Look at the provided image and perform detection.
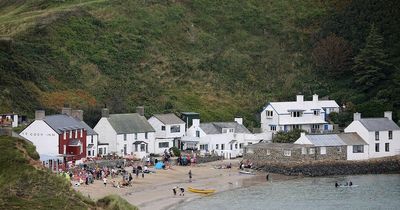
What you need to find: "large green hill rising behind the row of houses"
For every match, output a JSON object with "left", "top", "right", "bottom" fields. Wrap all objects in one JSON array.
[{"left": 0, "top": 0, "right": 400, "bottom": 127}]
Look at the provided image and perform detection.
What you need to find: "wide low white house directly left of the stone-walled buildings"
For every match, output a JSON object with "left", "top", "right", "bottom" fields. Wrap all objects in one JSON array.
[{"left": 186, "top": 118, "right": 260, "bottom": 158}]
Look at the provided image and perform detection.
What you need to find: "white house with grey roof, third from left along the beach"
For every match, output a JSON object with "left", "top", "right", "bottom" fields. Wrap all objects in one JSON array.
[{"left": 148, "top": 114, "right": 185, "bottom": 154}]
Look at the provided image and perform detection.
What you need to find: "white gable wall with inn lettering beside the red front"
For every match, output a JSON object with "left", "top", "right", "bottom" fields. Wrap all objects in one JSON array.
[{"left": 20, "top": 120, "right": 59, "bottom": 155}]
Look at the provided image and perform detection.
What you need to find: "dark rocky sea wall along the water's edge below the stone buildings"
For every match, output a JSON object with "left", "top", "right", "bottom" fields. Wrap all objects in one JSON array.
[{"left": 254, "top": 156, "right": 400, "bottom": 176}]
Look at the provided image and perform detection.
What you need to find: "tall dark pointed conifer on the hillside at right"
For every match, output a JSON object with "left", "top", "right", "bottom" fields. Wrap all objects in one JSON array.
[{"left": 353, "top": 24, "right": 392, "bottom": 91}]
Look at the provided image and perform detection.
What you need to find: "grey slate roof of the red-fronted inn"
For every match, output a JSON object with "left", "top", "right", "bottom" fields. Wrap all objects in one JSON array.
[{"left": 43, "top": 114, "right": 85, "bottom": 134}]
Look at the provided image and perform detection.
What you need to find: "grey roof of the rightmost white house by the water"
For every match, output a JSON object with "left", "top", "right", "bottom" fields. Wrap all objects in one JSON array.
[{"left": 359, "top": 117, "right": 400, "bottom": 131}]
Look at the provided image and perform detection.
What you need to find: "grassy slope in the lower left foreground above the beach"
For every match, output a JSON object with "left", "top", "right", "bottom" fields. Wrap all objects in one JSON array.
[{"left": 0, "top": 137, "right": 136, "bottom": 210}]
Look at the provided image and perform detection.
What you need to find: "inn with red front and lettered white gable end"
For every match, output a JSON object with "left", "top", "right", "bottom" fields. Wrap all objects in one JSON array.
[{"left": 20, "top": 109, "right": 88, "bottom": 160}]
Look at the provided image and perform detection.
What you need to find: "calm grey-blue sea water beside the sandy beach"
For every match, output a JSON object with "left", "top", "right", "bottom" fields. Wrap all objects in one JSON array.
[{"left": 175, "top": 174, "right": 400, "bottom": 210}]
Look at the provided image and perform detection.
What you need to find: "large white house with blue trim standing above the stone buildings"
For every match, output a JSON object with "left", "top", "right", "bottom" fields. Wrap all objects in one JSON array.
[{"left": 261, "top": 95, "right": 339, "bottom": 133}]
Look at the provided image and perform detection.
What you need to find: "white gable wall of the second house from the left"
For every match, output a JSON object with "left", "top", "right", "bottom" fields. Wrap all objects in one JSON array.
[{"left": 93, "top": 117, "right": 117, "bottom": 154}]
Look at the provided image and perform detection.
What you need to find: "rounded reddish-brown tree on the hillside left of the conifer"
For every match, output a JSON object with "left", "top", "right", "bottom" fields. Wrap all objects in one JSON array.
[{"left": 312, "top": 34, "right": 353, "bottom": 77}]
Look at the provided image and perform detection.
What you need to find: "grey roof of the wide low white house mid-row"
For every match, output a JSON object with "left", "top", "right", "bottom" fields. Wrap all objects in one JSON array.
[{"left": 200, "top": 122, "right": 250, "bottom": 134}]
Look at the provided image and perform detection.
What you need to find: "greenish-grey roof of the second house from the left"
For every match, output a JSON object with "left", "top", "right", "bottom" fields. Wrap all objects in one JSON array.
[{"left": 108, "top": 113, "right": 155, "bottom": 134}]
